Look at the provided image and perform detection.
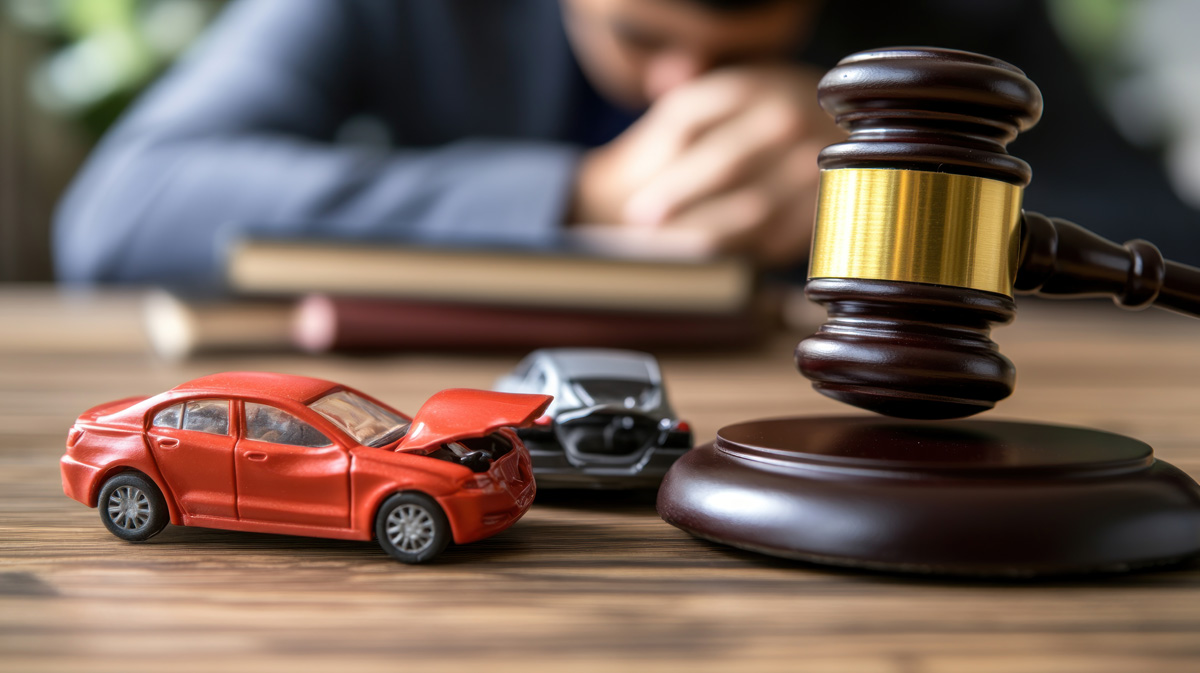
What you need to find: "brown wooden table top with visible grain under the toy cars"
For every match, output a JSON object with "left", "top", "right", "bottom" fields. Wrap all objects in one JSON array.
[{"left": 0, "top": 287, "right": 1200, "bottom": 673}]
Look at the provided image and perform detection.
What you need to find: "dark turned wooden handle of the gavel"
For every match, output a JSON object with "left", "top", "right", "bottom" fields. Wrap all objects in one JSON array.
[{"left": 1013, "top": 211, "right": 1200, "bottom": 317}]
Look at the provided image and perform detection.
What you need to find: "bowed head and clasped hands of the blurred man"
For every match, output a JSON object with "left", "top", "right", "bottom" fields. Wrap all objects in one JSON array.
[{"left": 564, "top": 0, "right": 841, "bottom": 265}]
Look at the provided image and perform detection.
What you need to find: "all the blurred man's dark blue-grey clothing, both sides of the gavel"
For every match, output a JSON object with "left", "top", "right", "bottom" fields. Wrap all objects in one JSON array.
[{"left": 55, "top": 0, "right": 1200, "bottom": 284}]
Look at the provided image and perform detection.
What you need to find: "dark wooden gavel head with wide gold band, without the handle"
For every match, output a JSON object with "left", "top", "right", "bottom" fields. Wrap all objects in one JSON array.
[{"left": 796, "top": 48, "right": 1042, "bottom": 419}]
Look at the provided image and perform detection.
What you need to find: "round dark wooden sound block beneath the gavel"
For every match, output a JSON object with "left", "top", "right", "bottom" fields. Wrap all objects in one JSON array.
[{"left": 658, "top": 416, "right": 1200, "bottom": 576}]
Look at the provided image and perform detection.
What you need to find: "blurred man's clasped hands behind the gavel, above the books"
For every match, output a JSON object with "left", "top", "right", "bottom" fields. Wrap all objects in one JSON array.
[{"left": 572, "top": 66, "right": 845, "bottom": 265}]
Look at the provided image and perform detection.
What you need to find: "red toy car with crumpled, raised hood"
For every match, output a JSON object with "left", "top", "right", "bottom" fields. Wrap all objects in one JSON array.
[{"left": 61, "top": 372, "right": 551, "bottom": 563}]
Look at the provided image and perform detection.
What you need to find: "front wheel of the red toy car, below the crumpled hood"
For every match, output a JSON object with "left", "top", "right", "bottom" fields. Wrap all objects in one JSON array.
[{"left": 376, "top": 493, "right": 450, "bottom": 563}]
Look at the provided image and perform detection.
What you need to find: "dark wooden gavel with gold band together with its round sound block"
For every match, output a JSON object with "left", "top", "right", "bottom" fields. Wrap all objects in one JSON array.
[{"left": 659, "top": 48, "right": 1200, "bottom": 576}]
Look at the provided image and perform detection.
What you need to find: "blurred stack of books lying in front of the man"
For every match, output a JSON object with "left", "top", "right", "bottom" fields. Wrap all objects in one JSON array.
[{"left": 146, "top": 229, "right": 763, "bottom": 359}]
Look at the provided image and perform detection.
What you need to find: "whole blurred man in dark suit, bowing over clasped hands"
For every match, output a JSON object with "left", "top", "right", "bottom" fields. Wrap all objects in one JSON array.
[{"left": 55, "top": 0, "right": 1200, "bottom": 284}]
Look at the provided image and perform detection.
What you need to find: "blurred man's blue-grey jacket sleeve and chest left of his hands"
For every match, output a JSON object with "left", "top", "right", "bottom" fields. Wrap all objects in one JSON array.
[{"left": 55, "top": 0, "right": 604, "bottom": 284}]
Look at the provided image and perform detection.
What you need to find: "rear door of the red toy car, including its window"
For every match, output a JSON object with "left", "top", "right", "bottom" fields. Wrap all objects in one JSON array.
[{"left": 146, "top": 399, "right": 238, "bottom": 518}]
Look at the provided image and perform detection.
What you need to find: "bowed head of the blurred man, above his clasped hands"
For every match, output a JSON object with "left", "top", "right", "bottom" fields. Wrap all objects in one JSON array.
[{"left": 562, "top": 0, "right": 820, "bottom": 108}]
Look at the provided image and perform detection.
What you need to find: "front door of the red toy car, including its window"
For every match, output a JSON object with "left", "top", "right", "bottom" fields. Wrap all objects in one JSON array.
[{"left": 234, "top": 402, "right": 350, "bottom": 528}]
